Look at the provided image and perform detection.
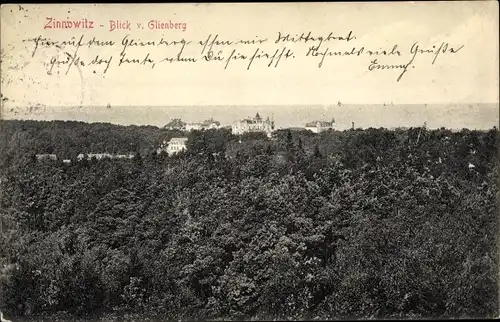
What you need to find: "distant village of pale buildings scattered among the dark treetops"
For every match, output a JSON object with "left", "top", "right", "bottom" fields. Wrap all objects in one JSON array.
[{"left": 36, "top": 113, "right": 335, "bottom": 164}]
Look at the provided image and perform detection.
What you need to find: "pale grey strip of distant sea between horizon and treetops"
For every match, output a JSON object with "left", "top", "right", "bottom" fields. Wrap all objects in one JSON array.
[{"left": 2, "top": 103, "right": 499, "bottom": 130}]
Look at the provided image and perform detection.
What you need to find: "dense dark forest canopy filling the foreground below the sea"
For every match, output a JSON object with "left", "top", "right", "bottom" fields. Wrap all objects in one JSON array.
[{"left": 0, "top": 121, "right": 499, "bottom": 319}]
